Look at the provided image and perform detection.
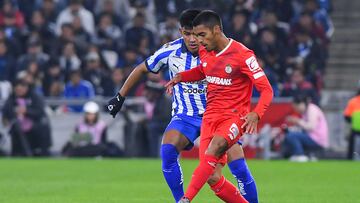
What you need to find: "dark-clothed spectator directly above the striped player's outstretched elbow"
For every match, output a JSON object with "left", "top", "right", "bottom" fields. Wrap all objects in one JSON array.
[{"left": 125, "top": 13, "right": 155, "bottom": 52}]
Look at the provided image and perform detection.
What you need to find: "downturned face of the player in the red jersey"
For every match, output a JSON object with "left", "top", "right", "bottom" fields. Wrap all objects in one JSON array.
[{"left": 194, "top": 25, "right": 216, "bottom": 51}]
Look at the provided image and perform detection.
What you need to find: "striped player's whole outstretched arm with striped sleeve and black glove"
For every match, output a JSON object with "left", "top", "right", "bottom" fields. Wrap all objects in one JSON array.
[{"left": 107, "top": 45, "right": 173, "bottom": 118}]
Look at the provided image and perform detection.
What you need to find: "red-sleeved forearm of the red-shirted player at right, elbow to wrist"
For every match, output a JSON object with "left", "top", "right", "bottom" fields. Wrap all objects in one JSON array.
[{"left": 254, "top": 79, "right": 274, "bottom": 118}]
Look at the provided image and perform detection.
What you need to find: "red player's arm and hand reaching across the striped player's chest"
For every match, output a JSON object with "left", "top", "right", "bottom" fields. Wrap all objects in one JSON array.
[{"left": 165, "top": 64, "right": 205, "bottom": 94}]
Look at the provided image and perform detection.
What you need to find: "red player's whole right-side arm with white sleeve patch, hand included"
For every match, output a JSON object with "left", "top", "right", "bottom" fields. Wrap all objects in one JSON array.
[{"left": 241, "top": 51, "right": 274, "bottom": 134}]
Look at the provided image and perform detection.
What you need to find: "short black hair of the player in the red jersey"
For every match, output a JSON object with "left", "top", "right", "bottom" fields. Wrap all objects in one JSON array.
[{"left": 193, "top": 10, "right": 223, "bottom": 30}]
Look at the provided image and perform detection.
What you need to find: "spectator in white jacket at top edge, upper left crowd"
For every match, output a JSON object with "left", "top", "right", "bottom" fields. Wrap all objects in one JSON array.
[{"left": 56, "top": 0, "right": 95, "bottom": 35}]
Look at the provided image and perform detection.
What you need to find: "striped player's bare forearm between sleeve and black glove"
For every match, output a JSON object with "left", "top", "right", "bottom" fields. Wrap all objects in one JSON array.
[{"left": 119, "top": 63, "right": 148, "bottom": 97}]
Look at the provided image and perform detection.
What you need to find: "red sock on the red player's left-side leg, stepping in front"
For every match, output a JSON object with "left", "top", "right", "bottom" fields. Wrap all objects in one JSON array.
[{"left": 184, "top": 155, "right": 218, "bottom": 200}]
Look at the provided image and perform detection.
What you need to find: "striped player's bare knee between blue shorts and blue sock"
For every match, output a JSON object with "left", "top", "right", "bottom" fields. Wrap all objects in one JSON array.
[{"left": 162, "top": 129, "right": 190, "bottom": 152}]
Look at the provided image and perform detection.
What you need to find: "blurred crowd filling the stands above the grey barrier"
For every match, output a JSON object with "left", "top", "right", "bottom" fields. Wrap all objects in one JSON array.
[{"left": 0, "top": 0, "right": 334, "bottom": 104}]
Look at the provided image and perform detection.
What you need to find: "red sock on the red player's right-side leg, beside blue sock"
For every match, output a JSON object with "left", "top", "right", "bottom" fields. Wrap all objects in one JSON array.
[{"left": 211, "top": 176, "right": 248, "bottom": 203}]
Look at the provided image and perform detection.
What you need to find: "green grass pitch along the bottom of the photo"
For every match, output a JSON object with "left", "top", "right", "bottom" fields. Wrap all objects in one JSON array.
[{"left": 0, "top": 159, "right": 360, "bottom": 203}]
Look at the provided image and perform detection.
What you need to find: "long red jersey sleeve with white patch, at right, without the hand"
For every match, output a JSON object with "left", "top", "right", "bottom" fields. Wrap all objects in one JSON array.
[{"left": 241, "top": 50, "right": 273, "bottom": 118}]
